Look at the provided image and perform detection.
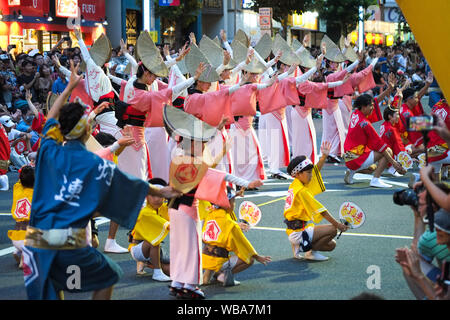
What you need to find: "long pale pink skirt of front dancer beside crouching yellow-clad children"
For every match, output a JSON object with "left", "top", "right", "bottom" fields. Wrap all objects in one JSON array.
[{"left": 169, "top": 200, "right": 203, "bottom": 286}]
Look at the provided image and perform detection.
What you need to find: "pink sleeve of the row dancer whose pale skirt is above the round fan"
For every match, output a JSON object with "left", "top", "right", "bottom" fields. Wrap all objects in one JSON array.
[{"left": 231, "top": 84, "right": 258, "bottom": 116}]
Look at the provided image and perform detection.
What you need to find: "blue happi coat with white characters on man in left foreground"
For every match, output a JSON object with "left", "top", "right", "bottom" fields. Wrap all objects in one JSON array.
[{"left": 24, "top": 119, "right": 149, "bottom": 299}]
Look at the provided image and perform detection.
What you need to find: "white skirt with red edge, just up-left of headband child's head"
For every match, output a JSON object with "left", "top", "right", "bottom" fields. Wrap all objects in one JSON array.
[{"left": 258, "top": 108, "right": 290, "bottom": 174}]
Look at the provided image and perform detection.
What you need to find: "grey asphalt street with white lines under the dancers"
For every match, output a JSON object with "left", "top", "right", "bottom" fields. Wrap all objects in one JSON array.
[{"left": 0, "top": 113, "right": 417, "bottom": 301}]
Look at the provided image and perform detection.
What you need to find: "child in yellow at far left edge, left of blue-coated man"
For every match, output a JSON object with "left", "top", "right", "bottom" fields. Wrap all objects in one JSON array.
[{"left": 8, "top": 166, "right": 34, "bottom": 268}]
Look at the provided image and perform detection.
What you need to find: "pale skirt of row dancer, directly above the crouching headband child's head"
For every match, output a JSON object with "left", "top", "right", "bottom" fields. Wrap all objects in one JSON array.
[{"left": 289, "top": 106, "right": 319, "bottom": 163}]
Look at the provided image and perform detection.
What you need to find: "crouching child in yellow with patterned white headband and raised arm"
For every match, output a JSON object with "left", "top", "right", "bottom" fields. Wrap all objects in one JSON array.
[{"left": 284, "top": 149, "right": 347, "bottom": 261}]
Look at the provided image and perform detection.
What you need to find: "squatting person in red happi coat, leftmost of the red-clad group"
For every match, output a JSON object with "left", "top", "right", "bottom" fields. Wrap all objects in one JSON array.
[{"left": 343, "top": 94, "right": 406, "bottom": 188}]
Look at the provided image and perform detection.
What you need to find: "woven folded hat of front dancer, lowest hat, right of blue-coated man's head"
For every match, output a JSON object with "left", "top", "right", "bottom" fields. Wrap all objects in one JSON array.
[{"left": 163, "top": 105, "right": 217, "bottom": 142}]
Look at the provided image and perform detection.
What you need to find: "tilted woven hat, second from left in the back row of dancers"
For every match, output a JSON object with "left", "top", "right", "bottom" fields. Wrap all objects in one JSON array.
[{"left": 136, "top": 31, "right": 169, "bottom": 77}]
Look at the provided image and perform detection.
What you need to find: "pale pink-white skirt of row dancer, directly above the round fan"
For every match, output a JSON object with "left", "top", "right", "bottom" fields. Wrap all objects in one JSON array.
[{"left": 229, "top": 116, "right": 266, "bottom": 181}]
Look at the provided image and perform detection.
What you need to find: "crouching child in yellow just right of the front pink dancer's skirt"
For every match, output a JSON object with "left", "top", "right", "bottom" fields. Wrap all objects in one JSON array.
[{"left": 202, "top": 187, "right": 271, "bottom": 286}]
